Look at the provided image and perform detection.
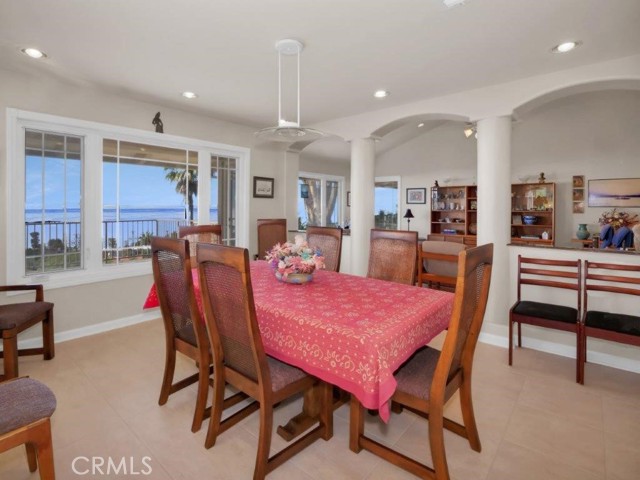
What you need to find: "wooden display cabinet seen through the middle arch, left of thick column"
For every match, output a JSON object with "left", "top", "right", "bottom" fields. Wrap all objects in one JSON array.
[{"left": 429, "top": 185, "right": 478, "bottom": 245}]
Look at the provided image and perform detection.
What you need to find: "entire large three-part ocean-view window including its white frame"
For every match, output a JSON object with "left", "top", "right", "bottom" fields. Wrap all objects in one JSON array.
[{"left": 10, "top": 108, "right": 250, "bottom": 288}]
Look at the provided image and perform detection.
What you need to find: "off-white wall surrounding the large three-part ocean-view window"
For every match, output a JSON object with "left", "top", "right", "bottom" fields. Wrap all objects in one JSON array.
[{"left": 0, "top": 69, "right": 285, "bottom": 338}]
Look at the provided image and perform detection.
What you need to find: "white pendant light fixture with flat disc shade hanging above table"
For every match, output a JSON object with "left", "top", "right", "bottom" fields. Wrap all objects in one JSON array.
[{"left": 256, "top": 38, "right": 326, "bottom": 142}]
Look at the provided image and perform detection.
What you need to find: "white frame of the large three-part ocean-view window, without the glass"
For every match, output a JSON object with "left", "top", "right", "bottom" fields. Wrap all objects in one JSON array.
[{"left": 5, "top": 108, "right": 251, "bottom": 289}]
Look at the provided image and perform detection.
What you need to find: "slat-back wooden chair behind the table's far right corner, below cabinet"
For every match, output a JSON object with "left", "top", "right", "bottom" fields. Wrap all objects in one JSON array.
[{"left": 418, "top": 240, "right": 466, "bottom": 290}]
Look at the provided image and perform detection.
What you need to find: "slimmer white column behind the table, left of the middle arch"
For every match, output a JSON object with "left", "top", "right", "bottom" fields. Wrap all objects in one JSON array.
[{"left": 351, "top": 138, "right": 376, "bottom": 276}]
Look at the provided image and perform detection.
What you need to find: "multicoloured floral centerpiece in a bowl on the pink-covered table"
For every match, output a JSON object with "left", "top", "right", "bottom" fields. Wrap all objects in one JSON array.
[{"left": 265, "top": 235, "right": 324, "bottom": 283}]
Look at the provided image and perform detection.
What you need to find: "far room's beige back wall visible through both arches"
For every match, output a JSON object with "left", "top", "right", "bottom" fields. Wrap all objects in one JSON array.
[{"left": 376, "top": 91, "right": 640, "bottom": 245}]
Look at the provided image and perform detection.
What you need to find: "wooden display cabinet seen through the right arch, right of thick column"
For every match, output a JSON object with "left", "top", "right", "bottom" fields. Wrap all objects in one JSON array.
[{"left": 511, "top": 183, "right": 556, "bottom": 246}]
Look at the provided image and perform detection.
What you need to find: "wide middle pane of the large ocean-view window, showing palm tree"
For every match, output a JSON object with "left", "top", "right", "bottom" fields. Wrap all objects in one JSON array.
[{"left": 102, "top": 139, "right": 198, "bottom": 265}]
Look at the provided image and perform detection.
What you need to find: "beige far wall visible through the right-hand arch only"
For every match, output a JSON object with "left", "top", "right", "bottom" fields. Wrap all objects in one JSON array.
[{"left": 511, "top": 91, "right": 640, "bottom": 244}]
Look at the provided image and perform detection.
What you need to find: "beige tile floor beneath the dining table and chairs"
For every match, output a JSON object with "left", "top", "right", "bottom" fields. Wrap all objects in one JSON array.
[{"left": 0, "top": 320, "right": 640, "bottom": 480}]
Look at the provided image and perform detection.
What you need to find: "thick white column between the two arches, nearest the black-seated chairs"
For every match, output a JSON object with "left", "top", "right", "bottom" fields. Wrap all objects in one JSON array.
[{"left": 478, "top": 116, "right": 511, "bottom": 325}]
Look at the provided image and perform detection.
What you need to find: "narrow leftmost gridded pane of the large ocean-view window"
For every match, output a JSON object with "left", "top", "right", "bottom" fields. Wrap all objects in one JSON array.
[{"left": 25, "top": 130, "right": 83, "bottom": 275}]
